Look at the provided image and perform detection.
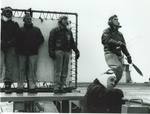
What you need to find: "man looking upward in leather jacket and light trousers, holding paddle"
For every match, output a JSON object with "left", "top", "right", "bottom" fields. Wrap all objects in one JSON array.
[{"left": 102, "top": 15, "right": 132, "bottom": 84}]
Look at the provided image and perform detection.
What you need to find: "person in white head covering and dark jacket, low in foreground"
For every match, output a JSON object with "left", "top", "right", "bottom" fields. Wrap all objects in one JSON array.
[{"left": 83, "top": 71, "right": 123, "bottom": 113}]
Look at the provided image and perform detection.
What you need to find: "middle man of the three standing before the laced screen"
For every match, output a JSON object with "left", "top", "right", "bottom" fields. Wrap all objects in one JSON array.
[{"left": 16, "top": 13, "right": 44, "bottom": 93}]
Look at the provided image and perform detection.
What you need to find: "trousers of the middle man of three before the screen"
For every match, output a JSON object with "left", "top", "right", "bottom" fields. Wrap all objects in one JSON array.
[{"left": 18, "top": 55, "right": 37, "bottom": 89}]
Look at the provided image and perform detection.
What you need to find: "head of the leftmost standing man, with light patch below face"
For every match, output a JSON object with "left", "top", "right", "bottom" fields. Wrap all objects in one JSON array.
[{"left": 2, "top": 7, "right": 13, "bottom": 21}]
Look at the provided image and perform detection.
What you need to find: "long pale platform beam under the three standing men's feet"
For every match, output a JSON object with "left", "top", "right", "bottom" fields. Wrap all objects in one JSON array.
[{"left": 0, "top": 93, "right": 84, "bottom": 102}]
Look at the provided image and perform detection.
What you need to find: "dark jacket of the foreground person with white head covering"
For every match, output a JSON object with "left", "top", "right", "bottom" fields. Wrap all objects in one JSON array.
[{"left": 84, "top": 79, "right": 123, "bottom": 113}]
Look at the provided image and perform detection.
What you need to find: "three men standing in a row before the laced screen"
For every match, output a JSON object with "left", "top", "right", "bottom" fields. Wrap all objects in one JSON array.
[{"left": 1, "top": 7, "right": 80, "bottom": 93}]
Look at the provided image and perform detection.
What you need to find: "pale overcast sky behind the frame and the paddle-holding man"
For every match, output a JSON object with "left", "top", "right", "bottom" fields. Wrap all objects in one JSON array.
[{"left": 1, "top": 0, "right": 150, "bottom": 82}]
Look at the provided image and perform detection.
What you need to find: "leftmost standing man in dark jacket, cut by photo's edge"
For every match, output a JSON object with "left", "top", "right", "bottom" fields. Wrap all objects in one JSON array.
[{"left": 1, "top": 7, "right": 19, "bottom": 93}]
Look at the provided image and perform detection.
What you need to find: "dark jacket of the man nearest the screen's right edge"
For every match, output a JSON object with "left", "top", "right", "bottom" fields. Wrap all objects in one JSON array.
[{"left": 48, "top": 27, "right": 78, "bottom": 53}]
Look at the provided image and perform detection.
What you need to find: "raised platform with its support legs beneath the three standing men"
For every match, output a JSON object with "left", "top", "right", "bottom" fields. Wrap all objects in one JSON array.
[{"left": 0, "top": 93, "right": 84, "bottom": 113}]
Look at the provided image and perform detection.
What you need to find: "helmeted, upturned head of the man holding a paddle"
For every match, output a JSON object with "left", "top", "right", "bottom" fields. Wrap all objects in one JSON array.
[{"left": 108, "top": 15, "right": 121, "bottom": 28}]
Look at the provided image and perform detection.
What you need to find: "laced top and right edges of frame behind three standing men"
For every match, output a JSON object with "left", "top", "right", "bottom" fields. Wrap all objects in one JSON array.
[{"left": 0, "top": 8, "right": 78, "bottom": 91}]
